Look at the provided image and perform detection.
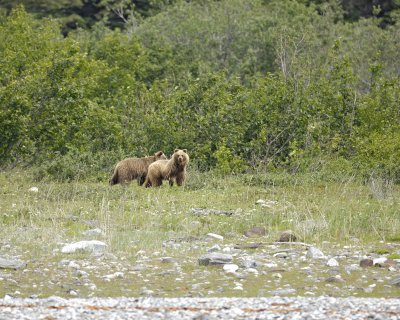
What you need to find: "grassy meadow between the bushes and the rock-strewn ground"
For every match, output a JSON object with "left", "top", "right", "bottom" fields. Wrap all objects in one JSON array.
[{"left": 0, "top": 170, "right": 400, "bottom": 296}]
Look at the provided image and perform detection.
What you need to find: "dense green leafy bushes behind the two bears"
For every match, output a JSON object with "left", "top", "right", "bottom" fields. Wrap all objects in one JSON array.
[{"left": 0, "top": 0, "right": 400, "bottom": 181}]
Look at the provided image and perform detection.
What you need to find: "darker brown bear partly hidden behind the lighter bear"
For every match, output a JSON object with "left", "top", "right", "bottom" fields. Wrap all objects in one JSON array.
[{"left": 110, "top": 151, "right": 167, "bottom": 186}]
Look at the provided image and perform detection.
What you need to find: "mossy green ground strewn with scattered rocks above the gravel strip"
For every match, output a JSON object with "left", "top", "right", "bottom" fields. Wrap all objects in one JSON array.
[{"left": 0, "top": 224, "right": 400, "bottom": 298}]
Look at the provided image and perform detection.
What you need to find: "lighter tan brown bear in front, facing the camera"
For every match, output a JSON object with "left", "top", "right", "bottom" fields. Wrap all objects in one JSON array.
[{"left": 144, "top": 149, "right": 189, "bottom": 188}]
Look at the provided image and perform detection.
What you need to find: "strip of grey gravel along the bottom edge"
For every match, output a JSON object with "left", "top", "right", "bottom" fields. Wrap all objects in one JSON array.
[{"left": 0, "top": 297, "right": 400, "bottom": 320}]
